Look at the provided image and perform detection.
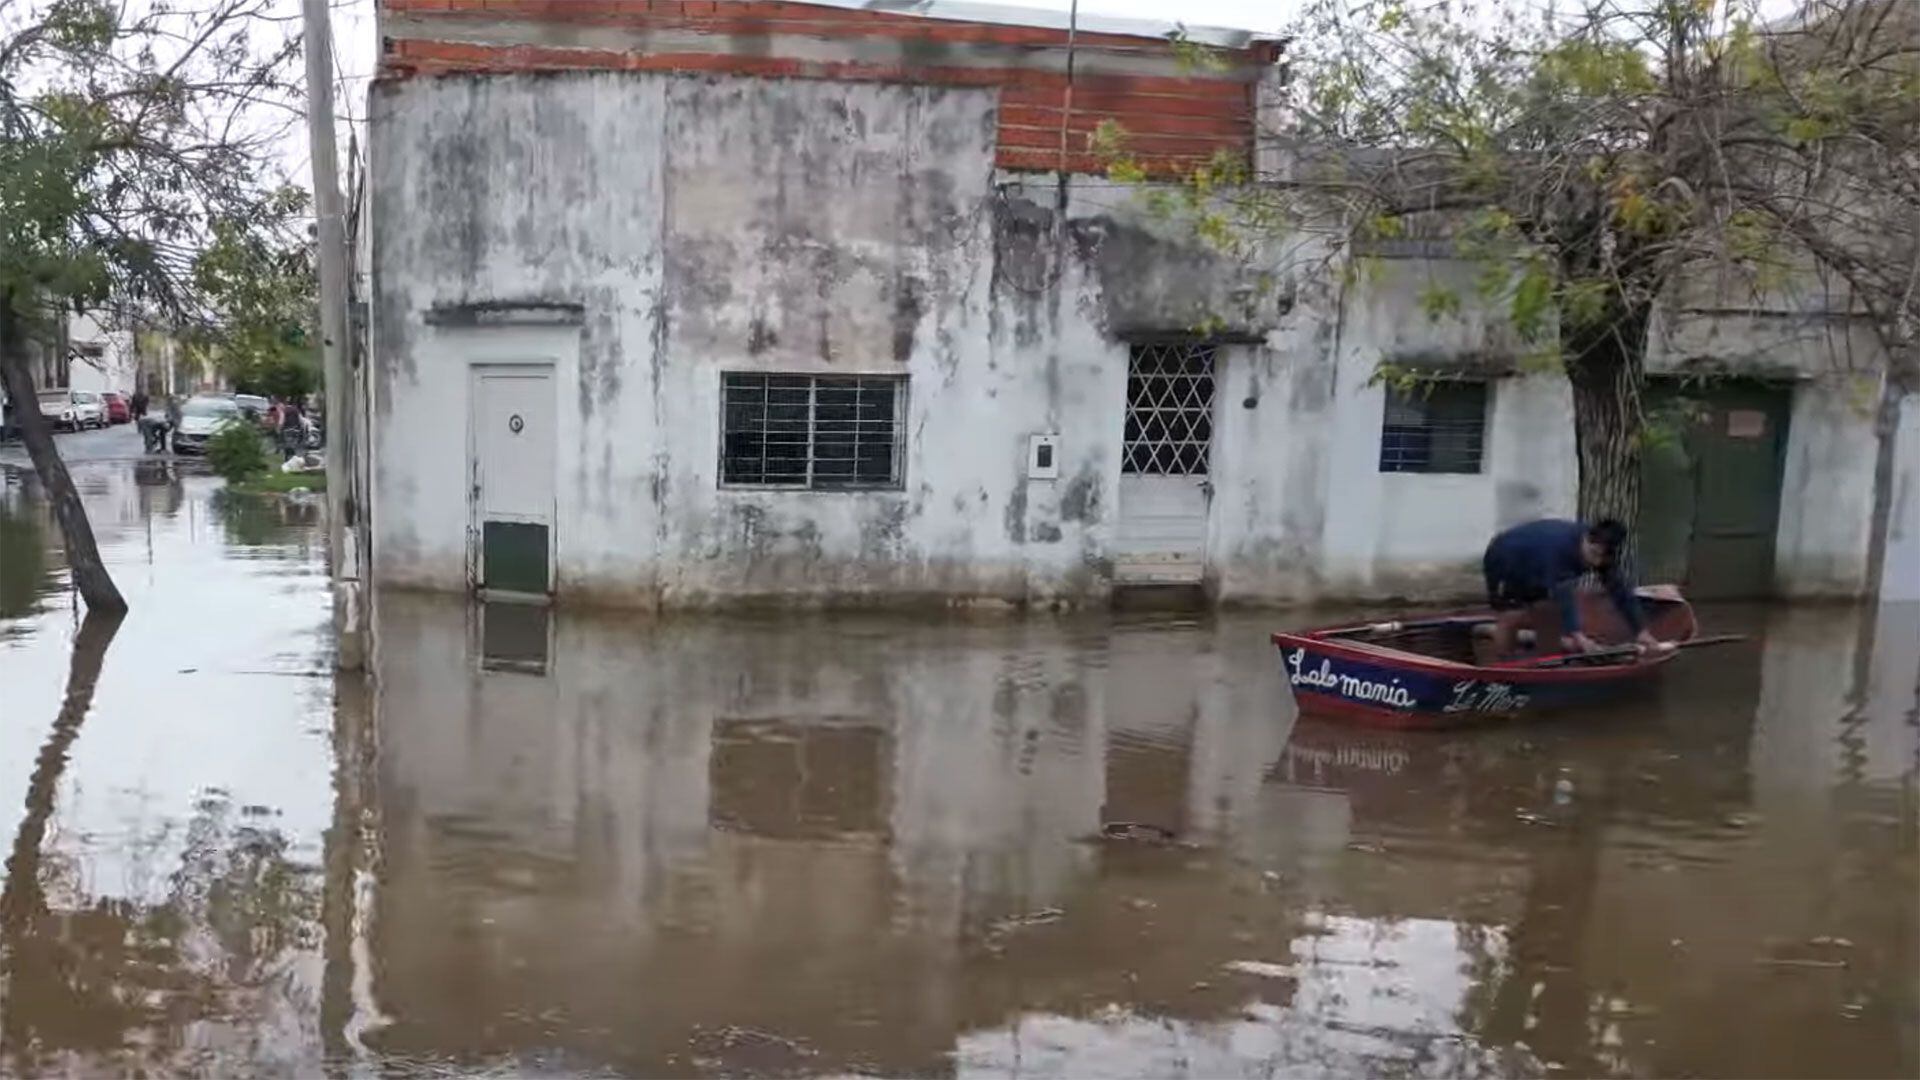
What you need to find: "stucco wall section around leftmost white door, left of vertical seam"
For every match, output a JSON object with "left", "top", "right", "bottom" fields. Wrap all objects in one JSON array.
[{"left": 371, "top": 75, "right": 666, "bottom": 594}]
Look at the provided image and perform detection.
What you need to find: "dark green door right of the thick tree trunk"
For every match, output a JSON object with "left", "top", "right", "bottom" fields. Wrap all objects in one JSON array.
[{"left": 1640, "top": 380, "right": 1791, "bottom": 600}]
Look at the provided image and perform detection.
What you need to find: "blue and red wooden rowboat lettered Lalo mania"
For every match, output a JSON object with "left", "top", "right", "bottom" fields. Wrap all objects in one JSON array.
[{"left": 1273, "top": 586, "right": 1697, "bottom": 728}]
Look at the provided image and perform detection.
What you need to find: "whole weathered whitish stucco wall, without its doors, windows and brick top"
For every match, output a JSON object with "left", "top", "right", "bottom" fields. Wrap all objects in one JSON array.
[{"left": 371, "top": 71, "right": 1872, "bottom": 607}]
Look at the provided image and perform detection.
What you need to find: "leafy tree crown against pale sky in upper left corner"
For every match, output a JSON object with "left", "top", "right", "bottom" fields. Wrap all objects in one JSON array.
[{"left": 0, "top": 0, "right": 303, "bottom": 340}]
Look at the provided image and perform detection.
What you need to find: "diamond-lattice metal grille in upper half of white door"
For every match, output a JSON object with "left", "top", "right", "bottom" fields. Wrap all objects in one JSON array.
[{"left": 1121, "top": 342, "right": 1213, "bottom": 477}]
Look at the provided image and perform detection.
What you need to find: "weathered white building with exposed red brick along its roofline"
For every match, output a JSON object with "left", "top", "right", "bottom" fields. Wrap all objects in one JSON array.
[{"left": 369, "top": 0, "right": 1896, "bottom": 607}]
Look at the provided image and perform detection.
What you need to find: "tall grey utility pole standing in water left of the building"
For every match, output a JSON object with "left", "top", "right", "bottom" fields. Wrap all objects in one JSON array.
[{"left": 303, "top": 0, "right": 367, "bottom": 671}]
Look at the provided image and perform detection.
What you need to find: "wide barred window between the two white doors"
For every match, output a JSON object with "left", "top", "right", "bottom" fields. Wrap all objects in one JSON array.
[{"left": 720, "top": 373, "right": 906, "bottom": 490}]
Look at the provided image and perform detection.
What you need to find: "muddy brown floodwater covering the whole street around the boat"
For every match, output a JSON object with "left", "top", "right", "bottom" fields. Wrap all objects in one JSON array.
[{"left": 0, "top": 461, "right": 1920, "bottom": 1076}]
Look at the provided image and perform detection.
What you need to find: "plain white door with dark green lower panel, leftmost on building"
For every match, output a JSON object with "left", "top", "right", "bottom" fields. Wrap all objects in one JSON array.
[{"left": 470, "top": 365, "right": 555, "bottom": 596}]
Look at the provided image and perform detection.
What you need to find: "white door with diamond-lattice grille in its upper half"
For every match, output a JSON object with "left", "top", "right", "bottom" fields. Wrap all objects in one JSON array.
[{"left": 1114, "top": 342, "right": 1213, "bottom": 584}]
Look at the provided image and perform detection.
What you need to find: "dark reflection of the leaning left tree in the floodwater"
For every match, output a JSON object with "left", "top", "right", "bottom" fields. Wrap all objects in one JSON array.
[{"left": 0, "top": 615, "right": 321, "bottom": 1074}]
